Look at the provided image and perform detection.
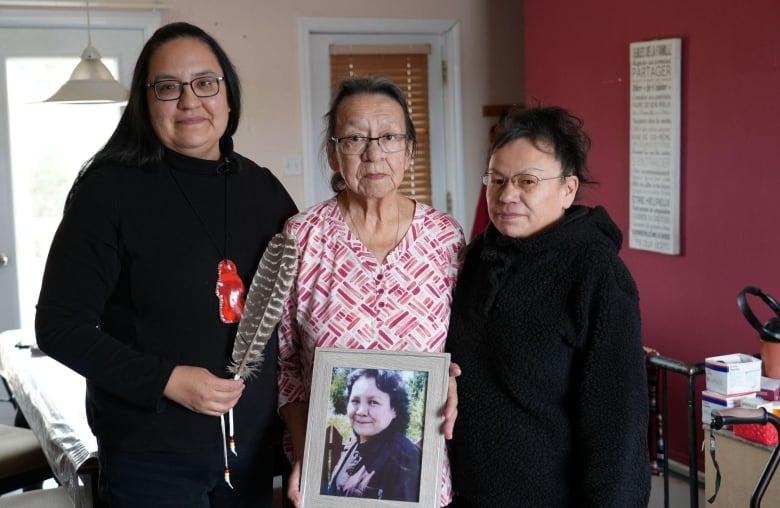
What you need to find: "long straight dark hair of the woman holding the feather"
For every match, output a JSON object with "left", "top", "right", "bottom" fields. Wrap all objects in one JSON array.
[{"left": 65, "top": 22, "right": 241, "bottom": 209}]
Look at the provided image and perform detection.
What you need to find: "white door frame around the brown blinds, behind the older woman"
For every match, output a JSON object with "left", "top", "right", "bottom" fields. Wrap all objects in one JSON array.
[{"left": 298, "top": 18, "right": 465, "bottom": 223}]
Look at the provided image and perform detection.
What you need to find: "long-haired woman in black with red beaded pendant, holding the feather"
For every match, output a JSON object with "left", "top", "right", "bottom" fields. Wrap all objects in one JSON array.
[{"left": 36, "top": 23, "right": 296, "bottom": 508}]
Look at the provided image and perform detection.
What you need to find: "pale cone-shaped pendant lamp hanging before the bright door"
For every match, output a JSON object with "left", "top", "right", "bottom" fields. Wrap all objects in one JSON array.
[{"left": 43, "top": 0, "right": 128, "bottom": 104}]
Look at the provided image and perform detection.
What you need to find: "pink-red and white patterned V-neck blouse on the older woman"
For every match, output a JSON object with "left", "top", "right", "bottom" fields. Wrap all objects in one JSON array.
[{"left": 279, "top": 197, "right": 465, "bottom": 506}]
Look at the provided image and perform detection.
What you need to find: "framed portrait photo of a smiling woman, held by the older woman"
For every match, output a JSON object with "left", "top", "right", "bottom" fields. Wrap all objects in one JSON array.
[{"left": 301, "top": 348, "right": 450, "bottom": 508}]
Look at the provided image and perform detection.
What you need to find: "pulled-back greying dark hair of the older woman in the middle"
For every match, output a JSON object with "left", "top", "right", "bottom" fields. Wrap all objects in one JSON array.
[{"left": 322, "top": 76, "right": 417, "bottom": 193}]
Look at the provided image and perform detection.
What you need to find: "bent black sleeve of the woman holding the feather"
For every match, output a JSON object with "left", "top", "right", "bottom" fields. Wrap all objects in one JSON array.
[{"left": 35, "top": 173, "right": 174, "bottom": 411}]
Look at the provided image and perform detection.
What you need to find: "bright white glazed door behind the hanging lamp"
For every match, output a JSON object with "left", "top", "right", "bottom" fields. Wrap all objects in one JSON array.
[{"left": 0, "top": 15, "right": 149, "bottom": 331}]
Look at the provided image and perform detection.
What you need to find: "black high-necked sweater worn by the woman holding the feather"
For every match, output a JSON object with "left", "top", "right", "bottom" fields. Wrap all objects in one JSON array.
[{"left": 36, "top": 151, "right": 296, "bottom": 451}]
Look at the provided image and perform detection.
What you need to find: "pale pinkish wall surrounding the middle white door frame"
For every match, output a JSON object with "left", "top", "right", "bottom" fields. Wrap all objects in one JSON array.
[{"left": 162, "top": 0, "right": 524, "bottom": 234}]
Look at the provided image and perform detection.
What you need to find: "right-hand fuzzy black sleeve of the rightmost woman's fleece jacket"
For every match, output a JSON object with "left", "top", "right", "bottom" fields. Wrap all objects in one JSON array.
[{"left": 576, "top": 256, "right": 650, "bottom": 508}]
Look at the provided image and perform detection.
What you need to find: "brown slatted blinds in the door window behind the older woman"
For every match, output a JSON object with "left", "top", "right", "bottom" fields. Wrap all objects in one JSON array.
[{"left": 330, "top": 44, "right": 433, "bottom": 205}]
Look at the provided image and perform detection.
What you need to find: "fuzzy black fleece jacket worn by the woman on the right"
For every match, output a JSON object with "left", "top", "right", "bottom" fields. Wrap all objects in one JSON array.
[{"left": 447, "top": 206, "right": 650, "bottom": 508}]
